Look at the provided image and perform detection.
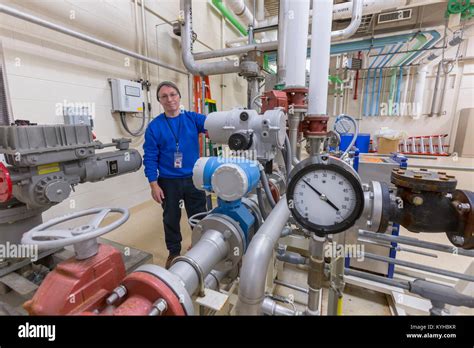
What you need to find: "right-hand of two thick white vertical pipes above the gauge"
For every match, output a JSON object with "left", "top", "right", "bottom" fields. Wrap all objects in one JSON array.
[{"left": 307, "top": 0, "right": 333, "bottom": 115}]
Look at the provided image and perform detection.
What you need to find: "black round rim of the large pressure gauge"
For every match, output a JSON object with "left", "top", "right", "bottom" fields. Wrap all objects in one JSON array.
[{"left": 286, "top": 155, "right": 364, "bottom": 235}]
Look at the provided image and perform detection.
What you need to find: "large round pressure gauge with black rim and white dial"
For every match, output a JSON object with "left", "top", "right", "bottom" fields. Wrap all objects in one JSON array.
[{"left": 286, "top": 155, "right": 364, "bottom": 235}]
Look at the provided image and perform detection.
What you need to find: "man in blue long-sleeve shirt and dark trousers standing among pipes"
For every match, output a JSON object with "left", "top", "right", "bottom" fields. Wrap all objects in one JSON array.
[{"left": 143, "top": 81, "right": 206, "bottom": 268}]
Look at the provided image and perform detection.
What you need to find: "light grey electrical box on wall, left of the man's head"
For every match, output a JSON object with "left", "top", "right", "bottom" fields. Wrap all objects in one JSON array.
[{"left": 109, "top": 79, "right": 143, "bottom": 113}]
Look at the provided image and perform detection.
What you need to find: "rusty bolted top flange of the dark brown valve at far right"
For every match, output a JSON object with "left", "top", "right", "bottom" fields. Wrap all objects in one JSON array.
[{"left": 390, "top": 168, "right": 457, "bottom": 192}]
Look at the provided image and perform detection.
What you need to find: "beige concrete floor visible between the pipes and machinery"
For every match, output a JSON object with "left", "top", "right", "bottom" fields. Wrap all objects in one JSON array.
[{"left": 104, "top": 157, "right": 474, "bottom": 315}]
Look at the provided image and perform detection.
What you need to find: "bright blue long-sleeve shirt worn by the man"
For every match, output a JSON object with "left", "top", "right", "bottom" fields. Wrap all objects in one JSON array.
[{"left": 143, "top": 111, "right": 206, "bottom": 182}]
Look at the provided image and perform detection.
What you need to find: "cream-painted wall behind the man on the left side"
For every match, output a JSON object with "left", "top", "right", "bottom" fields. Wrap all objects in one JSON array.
[{"left": 0, "top": 0, "right": 246, "bottom": 219}]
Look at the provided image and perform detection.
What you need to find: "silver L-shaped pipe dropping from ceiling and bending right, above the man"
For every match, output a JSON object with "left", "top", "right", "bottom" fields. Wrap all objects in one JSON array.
[{"left": 181, "top": 0, "right": 240, "bottom": 76}]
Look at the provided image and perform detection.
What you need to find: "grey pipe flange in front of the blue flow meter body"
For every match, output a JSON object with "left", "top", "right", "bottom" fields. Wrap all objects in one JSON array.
[{"left": 192, "top": 214, "right": 246, "bottom": 272}]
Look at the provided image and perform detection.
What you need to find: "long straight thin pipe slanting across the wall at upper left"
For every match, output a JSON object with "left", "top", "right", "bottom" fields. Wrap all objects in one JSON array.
[{"left": 0, "top": 4, "right": 188, "bottom": 75}]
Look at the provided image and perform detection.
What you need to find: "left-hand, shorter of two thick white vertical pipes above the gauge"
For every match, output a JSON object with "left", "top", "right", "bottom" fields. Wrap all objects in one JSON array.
[{"left": 284, "top": 0, "right": 310, "bottom": 87}]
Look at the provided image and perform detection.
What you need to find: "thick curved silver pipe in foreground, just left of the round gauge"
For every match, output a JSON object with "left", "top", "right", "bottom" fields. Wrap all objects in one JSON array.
[{"left": 235, "top": 196, "right": 290, "bottom": 315}]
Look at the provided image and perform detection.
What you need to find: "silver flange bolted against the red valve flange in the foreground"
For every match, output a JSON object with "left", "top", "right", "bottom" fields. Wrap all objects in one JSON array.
[{"left": 134, "top": 265, "right": 194, "bottom": 315}]
